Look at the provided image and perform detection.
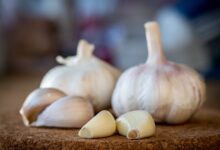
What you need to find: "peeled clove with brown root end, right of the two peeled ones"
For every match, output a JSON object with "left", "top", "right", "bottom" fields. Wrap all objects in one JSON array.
[{"left": 116, "top": 110, "right": 155, "bottom": 139}]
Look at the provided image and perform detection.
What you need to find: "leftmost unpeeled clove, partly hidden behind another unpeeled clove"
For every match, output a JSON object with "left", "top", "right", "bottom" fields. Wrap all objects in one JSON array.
[{"left": 20, "top": 88, "right": 66, "bottom": 126}]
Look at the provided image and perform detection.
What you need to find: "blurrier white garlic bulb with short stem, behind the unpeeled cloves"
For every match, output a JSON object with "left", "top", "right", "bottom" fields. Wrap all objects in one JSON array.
[{"left": 40, "top": 40, "right": 121, "bottom": 112}]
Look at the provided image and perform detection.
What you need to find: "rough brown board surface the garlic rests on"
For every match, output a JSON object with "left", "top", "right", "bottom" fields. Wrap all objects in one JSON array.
[{"left": 0, "top": 110, "right": 220, "bottom": 150}]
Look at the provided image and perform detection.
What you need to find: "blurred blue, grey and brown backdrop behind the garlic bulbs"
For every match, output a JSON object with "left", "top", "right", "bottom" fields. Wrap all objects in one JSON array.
[{"left": 0, "top": 0, "right": 220, "bottom": 111}]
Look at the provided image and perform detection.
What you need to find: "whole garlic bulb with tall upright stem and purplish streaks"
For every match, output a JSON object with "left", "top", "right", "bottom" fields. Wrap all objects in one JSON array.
[{"left": 112, "top": 22, "right": 205, "bottom": 124}]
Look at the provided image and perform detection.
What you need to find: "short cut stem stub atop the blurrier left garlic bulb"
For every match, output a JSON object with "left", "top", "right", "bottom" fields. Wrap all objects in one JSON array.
[{"left": 77, "top": 40, "right": 95, "bottom": 58}]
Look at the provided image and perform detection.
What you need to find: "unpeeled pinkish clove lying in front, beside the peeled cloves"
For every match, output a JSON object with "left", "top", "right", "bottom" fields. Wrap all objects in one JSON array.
[{"left": 31, "top": 96, "right": 94, "bottom": 128}]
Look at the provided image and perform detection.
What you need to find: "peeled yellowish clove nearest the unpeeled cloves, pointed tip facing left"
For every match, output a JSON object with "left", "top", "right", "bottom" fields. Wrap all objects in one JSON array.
[{"left": 78, "top": 110, "right": 116, "bottom": 138}]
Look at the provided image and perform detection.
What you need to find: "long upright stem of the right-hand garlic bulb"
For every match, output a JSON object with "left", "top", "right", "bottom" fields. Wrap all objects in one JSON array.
[{"left": 144, "top": 22, "right": 166, "bottom": 64}]
